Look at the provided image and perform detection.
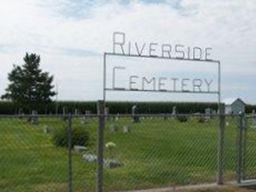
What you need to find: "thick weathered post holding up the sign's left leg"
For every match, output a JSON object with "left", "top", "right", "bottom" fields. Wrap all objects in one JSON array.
[{"left": 96, "top": 101, "right": 105, "bottom": 192}]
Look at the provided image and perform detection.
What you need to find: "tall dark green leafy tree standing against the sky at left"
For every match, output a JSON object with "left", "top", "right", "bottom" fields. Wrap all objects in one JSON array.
[{"left": 2, "top": 53, "right": 56, "bottom": 112}]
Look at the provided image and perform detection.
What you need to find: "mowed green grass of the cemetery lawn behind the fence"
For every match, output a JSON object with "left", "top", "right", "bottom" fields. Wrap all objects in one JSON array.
[{"left": 0, "top": 117, "right": 256, "bottom": 192}]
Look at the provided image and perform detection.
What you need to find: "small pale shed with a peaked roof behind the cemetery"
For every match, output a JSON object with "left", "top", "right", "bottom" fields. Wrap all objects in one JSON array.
[{"left": 223, "top": 98, "right": 246, "bottom": 115}]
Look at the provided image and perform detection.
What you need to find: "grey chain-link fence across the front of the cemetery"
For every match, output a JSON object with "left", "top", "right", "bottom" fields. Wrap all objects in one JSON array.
[{"left": 0, "top": 114, "right": 256, "bottom": 192}]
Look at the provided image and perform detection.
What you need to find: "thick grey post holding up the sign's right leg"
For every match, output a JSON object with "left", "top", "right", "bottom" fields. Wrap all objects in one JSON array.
[{"left": 217, "top": 104, "right": 225, "bottom": 185}]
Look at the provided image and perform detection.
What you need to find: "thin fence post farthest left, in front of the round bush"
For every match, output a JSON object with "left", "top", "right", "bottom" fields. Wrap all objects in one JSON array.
[{"left": 68, "top": 114, "right": 72, "bottom": 192}]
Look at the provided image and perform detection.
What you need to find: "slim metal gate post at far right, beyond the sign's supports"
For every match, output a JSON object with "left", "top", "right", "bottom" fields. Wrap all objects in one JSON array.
[{"left": 237, "top": 113, "right": 244, "bottom": 183}]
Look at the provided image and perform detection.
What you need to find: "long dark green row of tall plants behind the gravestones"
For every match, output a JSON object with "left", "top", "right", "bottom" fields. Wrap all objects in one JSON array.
[{"left": 0, "top": 101, "right": 256, "bottom": 114}]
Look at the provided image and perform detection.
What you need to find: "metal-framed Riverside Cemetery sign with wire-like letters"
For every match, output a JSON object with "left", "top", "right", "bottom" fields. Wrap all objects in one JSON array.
[{"left": 103, "top": 32, "right": 221, "bottom": 103}]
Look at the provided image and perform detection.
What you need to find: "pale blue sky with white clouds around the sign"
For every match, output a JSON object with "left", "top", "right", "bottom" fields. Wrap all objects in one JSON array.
[{"left": 0, "top": 0, "right": 256, "bottom": 104}]
